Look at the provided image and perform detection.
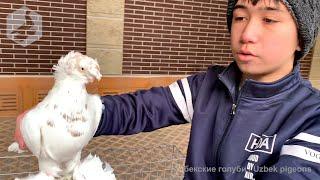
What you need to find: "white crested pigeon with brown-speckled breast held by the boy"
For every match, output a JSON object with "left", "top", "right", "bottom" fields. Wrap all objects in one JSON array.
[{"left": 9, "top": 51, "right": 107, "bottom": 178}]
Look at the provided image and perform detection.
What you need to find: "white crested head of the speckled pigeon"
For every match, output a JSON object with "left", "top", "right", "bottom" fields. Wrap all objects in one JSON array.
[{"left": 53, "top": 51, "right": 102, "bottom": 83}]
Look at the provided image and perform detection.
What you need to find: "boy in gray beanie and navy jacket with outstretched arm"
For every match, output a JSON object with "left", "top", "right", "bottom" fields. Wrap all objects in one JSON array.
[{"left": 18, "top": 0, "right": 320, "bottom": 180}]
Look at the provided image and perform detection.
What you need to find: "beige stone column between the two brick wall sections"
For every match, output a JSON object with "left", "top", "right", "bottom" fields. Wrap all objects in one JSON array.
[{"left": 87, "top": 0, "right": 124, "bottom": 74}]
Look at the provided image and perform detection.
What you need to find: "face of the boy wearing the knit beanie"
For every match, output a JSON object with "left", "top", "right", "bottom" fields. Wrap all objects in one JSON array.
[{"left": 231, "top": 0, "right": 300, "bottom": 82}]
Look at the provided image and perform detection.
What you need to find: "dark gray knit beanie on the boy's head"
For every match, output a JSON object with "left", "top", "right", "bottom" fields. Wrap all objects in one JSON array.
[{"left": 227, "top": 0, "right": 320, "bottom": 60}]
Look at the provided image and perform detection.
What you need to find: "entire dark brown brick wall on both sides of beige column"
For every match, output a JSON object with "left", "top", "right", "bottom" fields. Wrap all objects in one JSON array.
[{"left": 0, "top": 0, "right": 312, "bottom": 78}]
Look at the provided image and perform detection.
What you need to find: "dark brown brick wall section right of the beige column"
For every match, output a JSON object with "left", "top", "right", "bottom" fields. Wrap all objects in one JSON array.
[{"left": 122, "top": 0, "right": 312, "bottom": 77}]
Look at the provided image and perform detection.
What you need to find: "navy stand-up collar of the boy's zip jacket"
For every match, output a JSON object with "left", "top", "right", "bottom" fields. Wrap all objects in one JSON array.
[{"left": 218, "top": 62, "right": 302, "bottom": 99}]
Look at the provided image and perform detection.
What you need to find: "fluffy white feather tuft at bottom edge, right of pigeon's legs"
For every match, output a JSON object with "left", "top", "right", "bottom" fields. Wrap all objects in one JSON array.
[{"left": 73, "top": 154, "right": 116, "bottom": 180}]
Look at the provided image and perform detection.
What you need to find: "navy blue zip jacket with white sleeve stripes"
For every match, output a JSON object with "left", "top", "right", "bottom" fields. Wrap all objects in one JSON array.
[{"left": 95, "top": 63, "right": 320, "bottom": 180}]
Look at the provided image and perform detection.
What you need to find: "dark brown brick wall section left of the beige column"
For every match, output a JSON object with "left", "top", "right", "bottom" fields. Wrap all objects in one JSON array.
[{"left": 0, "top": 0, "right": 86, "bottom": 74}]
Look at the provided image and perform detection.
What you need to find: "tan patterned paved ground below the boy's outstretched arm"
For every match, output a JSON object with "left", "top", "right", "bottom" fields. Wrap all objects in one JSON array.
[{"left": 0, "top": 118, "right": 190, "bottom": 180}]
